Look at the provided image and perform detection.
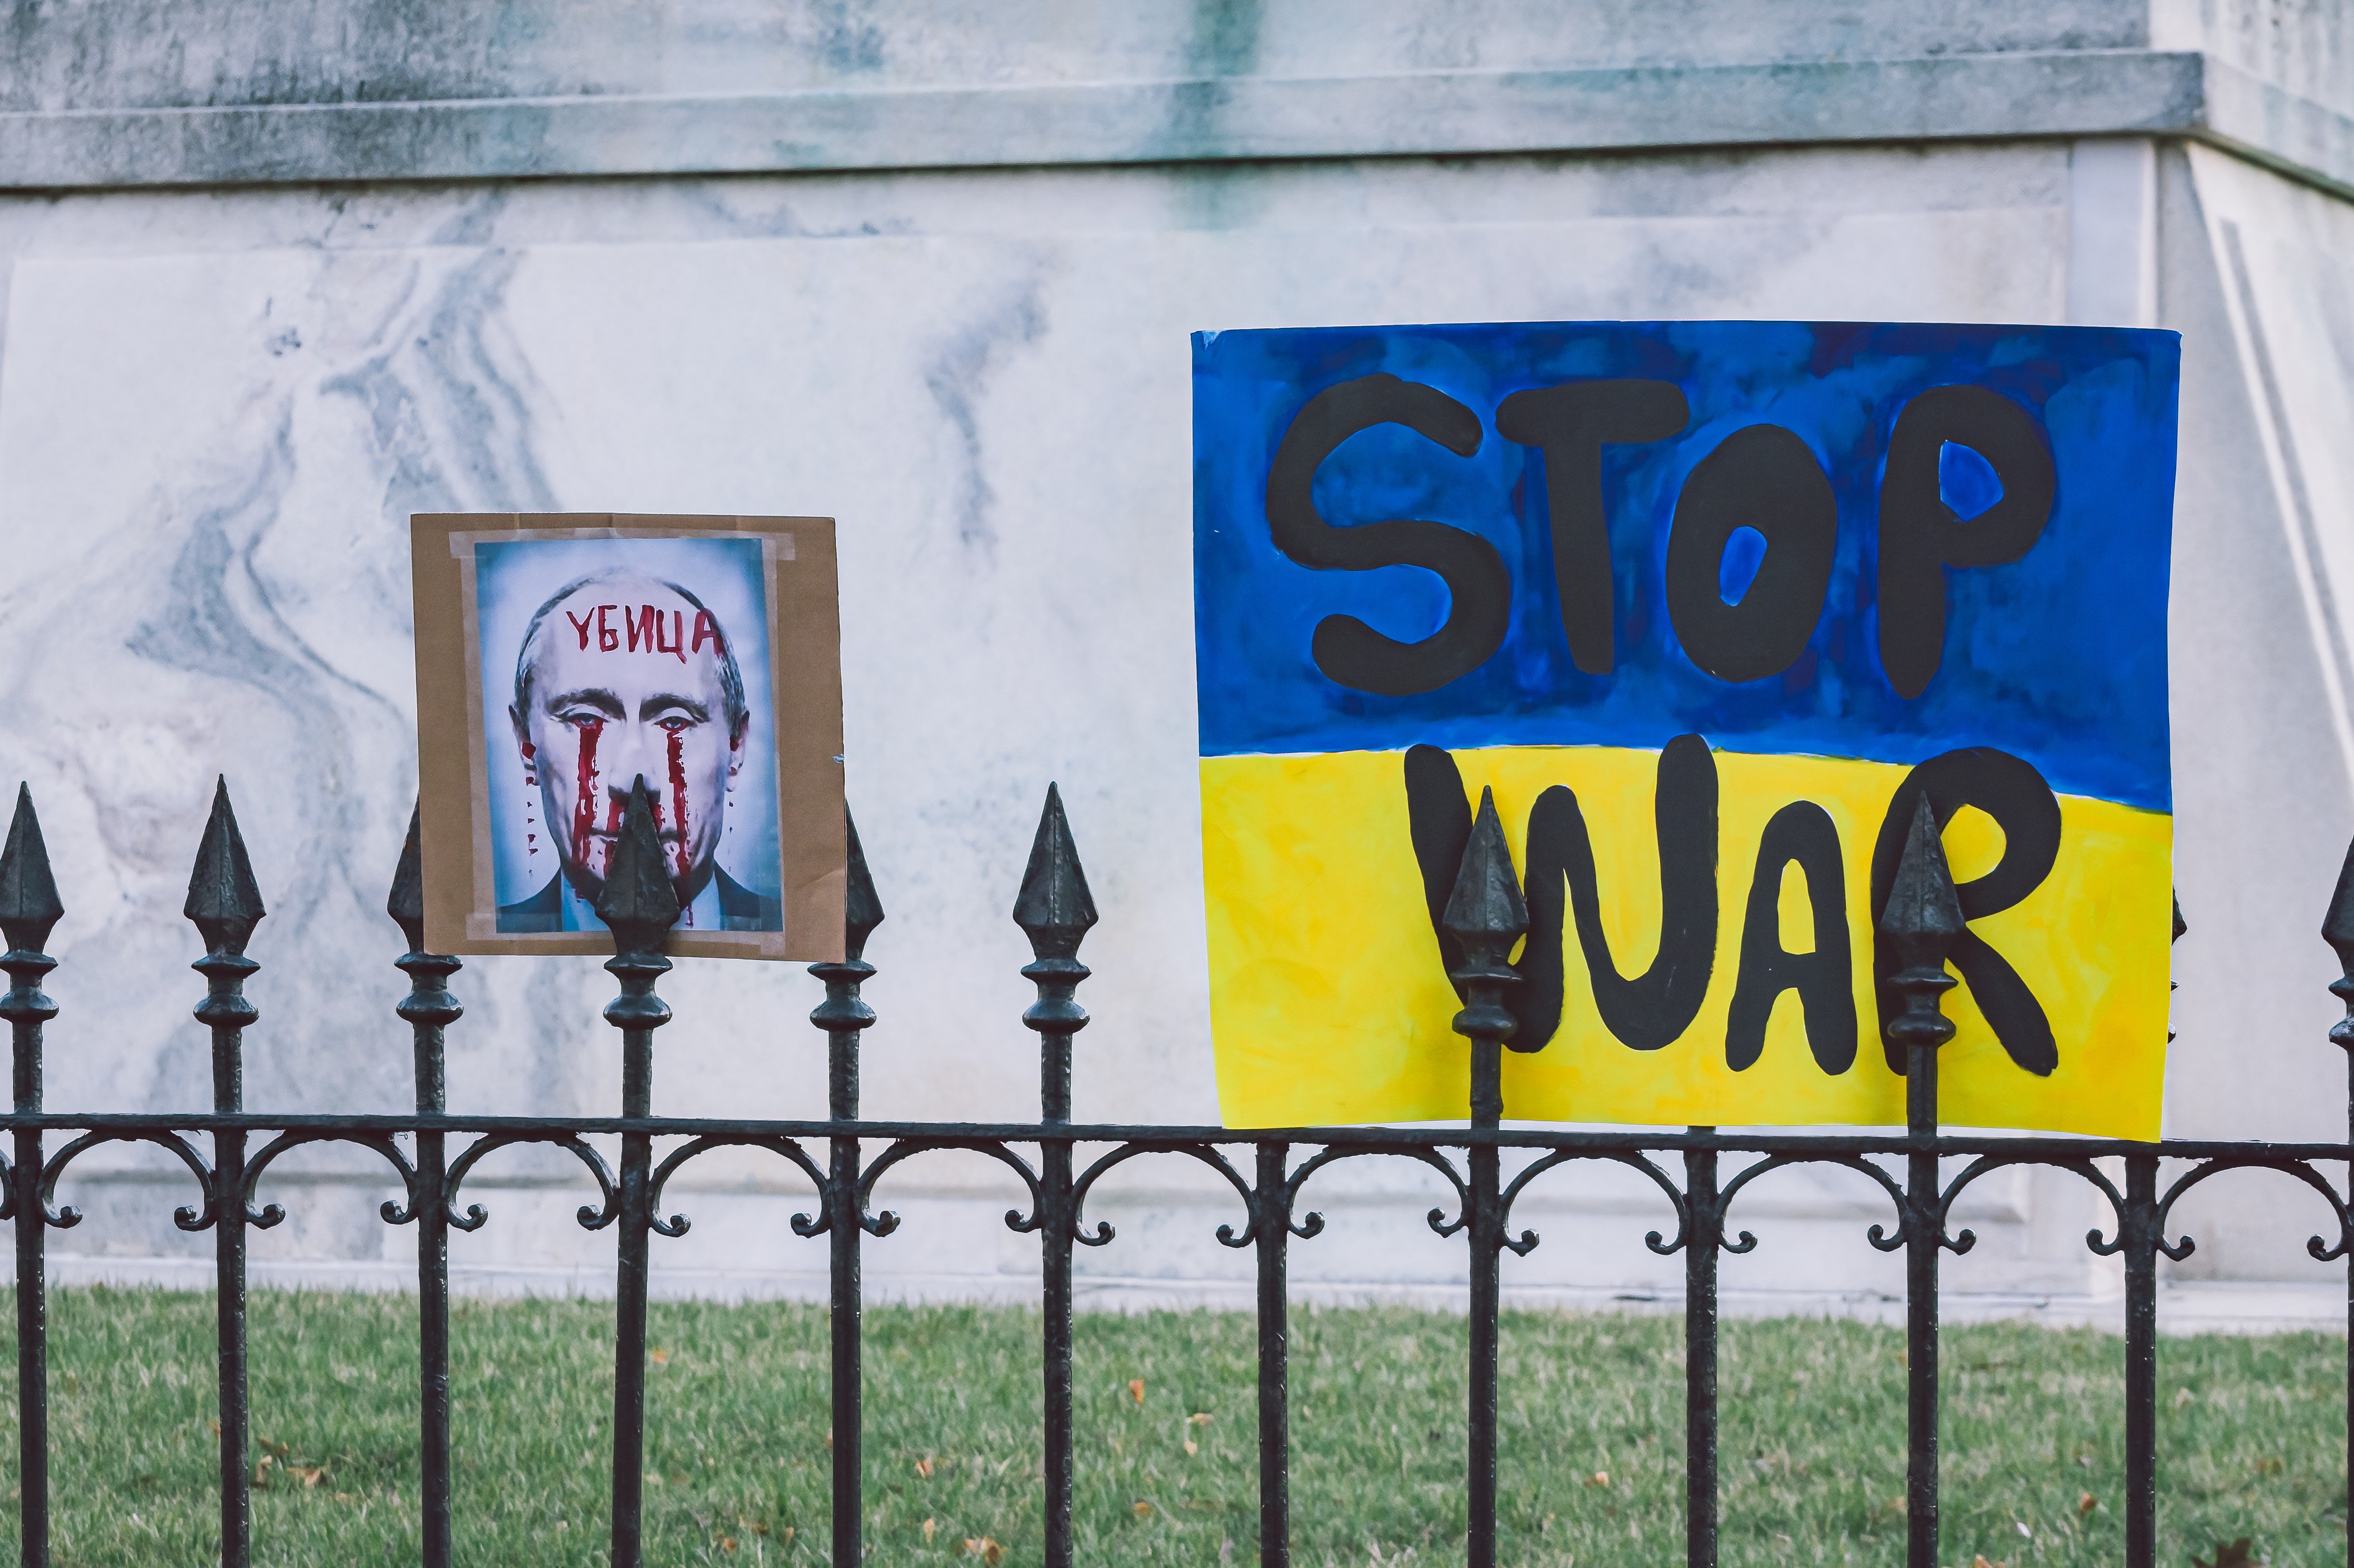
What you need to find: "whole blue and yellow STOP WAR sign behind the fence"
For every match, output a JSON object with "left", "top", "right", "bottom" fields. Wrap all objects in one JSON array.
[{"left": 1193, "top": 323, "right": 2180, "bottom": 1137}]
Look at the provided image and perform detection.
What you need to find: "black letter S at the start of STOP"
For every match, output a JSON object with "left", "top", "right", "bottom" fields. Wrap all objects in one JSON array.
[{"left": 1266, "top": 374, "right": 1511, "bottom": 697}]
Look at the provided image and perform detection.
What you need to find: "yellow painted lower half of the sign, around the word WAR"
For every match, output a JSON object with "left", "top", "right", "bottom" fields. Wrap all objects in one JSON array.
[{"left": 1200, "top": 746, "right": 2173, "bottom": 1137}]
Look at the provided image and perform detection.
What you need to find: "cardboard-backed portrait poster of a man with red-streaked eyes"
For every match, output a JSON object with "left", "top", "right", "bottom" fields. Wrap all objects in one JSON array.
[{"left": 410, "top": 513, "right": 845, "bottom": 960}]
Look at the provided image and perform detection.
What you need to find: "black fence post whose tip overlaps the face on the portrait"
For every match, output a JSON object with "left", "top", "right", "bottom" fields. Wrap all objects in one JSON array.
[{"left": 596, "top": 775, "right": 680, "bottom": 1568}]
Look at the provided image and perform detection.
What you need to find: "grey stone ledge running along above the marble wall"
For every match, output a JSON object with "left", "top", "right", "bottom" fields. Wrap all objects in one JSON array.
[{"left": 0, "top": 49, "right": 2354, "bottom": 191}]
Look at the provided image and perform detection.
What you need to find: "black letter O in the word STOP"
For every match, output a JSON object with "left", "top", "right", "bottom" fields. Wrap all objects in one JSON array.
[{"left": 1667, "top": 424, "right": 1839, "bottom": 680}]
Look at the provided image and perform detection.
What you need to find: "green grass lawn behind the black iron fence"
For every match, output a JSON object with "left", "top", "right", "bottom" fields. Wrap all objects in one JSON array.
[{"left": 0, "top": 1290, "right": 2347, "bottom": 1568}]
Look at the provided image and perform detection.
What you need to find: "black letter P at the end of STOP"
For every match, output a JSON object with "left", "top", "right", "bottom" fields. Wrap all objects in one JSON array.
[{"left": 1878, "top": 386, "right": 2060, "bottom": 697}]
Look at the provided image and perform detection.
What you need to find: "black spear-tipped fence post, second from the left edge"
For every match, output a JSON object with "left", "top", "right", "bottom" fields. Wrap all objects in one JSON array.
[{"left": 184, "top": 777, "right": 266, "bottom": 1568}]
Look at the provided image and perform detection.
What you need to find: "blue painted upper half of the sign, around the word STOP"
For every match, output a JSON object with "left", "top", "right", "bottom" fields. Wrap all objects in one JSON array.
[{"left": 1193, "top": 323, "right": 2180, "bottom": 810}]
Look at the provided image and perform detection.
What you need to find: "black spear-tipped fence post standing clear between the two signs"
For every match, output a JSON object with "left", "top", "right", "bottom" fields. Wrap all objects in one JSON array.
[{"left": 1015, "top": 784, "right": 1095, "bottom": 1568}]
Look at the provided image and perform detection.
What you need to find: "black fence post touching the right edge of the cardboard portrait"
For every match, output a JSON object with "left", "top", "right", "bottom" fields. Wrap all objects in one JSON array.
[{"left": 810, "top": 812, "right": 883, "bottom": 1568}]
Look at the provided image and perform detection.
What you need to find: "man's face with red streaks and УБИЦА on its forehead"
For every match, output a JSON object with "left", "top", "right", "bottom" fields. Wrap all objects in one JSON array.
[{"left": 509, "top": 577, "right": 744, "bottom": 899}]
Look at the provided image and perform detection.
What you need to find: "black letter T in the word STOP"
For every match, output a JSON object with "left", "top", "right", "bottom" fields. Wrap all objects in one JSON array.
[{"left": 1495, "top": 381, "right": 1693, "bottom": 676}]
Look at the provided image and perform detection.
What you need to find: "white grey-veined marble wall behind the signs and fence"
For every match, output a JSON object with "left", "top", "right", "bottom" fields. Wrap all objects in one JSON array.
[{"left": 0, "top": 146, "right": 2354, "bottom": 1290}]
